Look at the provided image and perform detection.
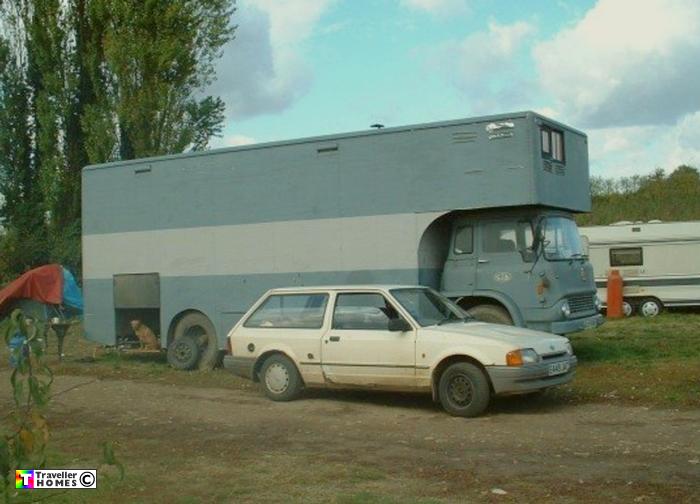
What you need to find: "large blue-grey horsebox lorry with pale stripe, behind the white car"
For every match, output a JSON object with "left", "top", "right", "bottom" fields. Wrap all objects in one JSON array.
[{"left": 82, "top": 112, "right": 602, "bottom": 368}]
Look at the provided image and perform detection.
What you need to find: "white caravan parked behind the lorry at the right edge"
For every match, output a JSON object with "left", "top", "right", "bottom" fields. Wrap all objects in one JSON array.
[{"left": 580, "top": 221, "right": 700, "bottom": 317}]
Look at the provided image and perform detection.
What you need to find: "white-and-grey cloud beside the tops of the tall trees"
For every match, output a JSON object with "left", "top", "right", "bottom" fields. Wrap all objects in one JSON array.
[{"left": 209, "top": 0, "right": 332, "bottom": 119}]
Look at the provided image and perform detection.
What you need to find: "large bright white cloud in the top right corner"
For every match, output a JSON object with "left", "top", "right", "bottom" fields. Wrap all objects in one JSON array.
[{"left": 533, "top": 0, "right": 700, "bottom": 127}]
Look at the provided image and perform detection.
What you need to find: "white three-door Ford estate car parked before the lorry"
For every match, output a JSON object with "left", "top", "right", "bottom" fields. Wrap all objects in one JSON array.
[{"left": 224, "top": 285, "right": 576, "bottom": 417}]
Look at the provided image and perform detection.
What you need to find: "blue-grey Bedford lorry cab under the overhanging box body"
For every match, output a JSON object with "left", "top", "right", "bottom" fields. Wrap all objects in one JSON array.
[{"left": 441, "top": 208, "right": 602, "bottom": 334}]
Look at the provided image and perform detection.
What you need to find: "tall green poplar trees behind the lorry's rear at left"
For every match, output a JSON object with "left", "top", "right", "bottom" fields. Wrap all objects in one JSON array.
[{"left": 0, "top": 0, "right": 235, "bottom": 282}]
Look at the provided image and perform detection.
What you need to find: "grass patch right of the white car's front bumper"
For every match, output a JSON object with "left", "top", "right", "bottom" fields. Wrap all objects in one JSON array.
[{"left": 553, "top": 313, "right": 700, "bottom": 407}]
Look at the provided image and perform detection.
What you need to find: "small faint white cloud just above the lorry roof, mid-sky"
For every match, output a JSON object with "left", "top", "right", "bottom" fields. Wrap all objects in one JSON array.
[{"left": 431, "top": 21, "right": 536, "bottom": 113}]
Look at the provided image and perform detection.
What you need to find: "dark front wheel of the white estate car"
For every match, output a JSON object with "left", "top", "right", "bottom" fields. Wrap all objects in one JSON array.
[{"left": 438, "top": 362, "right": 491, "bottom": 417}]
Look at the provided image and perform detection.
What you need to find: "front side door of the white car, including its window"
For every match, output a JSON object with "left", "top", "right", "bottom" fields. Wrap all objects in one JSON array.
[{"left": 321, "top": 292, "right": 416, "bottom": 388}]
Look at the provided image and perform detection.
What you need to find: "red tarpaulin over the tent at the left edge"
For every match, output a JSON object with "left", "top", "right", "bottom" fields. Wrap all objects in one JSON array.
[{"left": 0, "top": 264, "right": 63, "bottom": 312}]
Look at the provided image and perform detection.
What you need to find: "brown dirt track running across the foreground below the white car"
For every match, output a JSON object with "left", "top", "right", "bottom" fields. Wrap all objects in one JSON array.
[{"left": 0, "top": 373, "right": 700, "bottom": 502}]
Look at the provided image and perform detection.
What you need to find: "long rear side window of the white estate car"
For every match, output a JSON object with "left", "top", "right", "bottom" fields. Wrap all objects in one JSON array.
[{"left": 243, "top": 294, "right": 328, "bottom": 329}]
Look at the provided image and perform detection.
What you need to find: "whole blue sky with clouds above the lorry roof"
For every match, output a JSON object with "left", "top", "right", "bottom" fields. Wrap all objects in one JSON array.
[{"left": 211, "top": 0, "right": 700, "bottom": 176}]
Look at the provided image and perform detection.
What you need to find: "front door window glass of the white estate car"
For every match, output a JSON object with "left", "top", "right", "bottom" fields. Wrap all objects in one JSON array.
[{"left": 333, "top": 293, "right": 399, "bottom": 331}]
